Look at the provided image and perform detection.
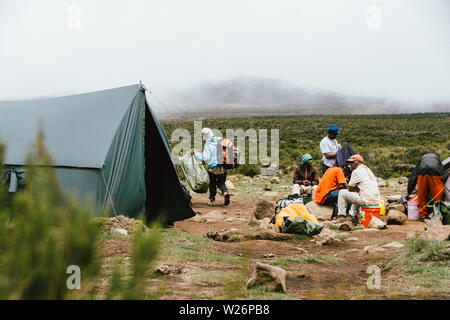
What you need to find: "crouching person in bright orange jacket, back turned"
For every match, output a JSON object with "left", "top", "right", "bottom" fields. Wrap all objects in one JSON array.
[{"left": 314, "top": 167, "right": 347, "bottom": 205}]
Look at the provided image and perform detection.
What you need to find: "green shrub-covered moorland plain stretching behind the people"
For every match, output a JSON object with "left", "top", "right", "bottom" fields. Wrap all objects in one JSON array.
[{"left": 162, "top": 113, "right": 450, "bottom": 179}]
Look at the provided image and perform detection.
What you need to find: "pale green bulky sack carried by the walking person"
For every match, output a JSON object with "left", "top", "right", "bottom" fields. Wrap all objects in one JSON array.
[{"left": 180, "top": 152, "right": 209, "bottom": 193}]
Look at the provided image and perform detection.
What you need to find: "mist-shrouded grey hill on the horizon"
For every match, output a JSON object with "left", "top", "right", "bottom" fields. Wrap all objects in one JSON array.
[{"left": 162, "top": 77, "right": 450, "bottom": 118}]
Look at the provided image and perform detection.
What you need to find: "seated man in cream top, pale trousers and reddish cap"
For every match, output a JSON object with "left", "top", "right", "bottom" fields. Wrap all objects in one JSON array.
[{"left": 338, "top": 154, "right": 381, "bottom": 224}]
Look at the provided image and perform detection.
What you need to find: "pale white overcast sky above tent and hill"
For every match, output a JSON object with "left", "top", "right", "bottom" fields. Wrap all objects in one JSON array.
[{"left": 0, "top": 0, "right": 450, "bottom": 102}]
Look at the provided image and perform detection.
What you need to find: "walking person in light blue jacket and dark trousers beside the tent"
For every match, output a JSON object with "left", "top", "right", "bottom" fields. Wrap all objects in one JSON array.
[{"left": 194, "top": 128, "right": 230, "bottom": 206}]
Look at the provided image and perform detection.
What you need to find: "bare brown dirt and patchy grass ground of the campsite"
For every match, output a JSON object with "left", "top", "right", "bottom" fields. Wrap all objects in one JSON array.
[{"left": 99, "top": 179, "right": 450, "bottom": 299}]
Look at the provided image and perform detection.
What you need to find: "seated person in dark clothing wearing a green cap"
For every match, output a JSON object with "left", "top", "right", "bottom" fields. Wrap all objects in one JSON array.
[{"left": 292, "top": 153, "right": 319, "bottom": 195}]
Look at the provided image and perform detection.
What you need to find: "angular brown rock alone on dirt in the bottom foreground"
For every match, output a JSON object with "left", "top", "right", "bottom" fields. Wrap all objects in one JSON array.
[{"left": 246, "top": 262, "right": 286, "bottom": 292}]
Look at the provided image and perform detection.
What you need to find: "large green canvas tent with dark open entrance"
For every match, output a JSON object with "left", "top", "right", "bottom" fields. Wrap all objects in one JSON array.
[{"left": 0, "top": 85, "right": 195, "bottom": 222}]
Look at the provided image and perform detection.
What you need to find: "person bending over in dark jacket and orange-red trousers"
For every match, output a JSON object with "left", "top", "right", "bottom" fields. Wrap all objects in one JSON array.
[{"left": 408, "top": 153, "right": 444, "bottom": 219}]
